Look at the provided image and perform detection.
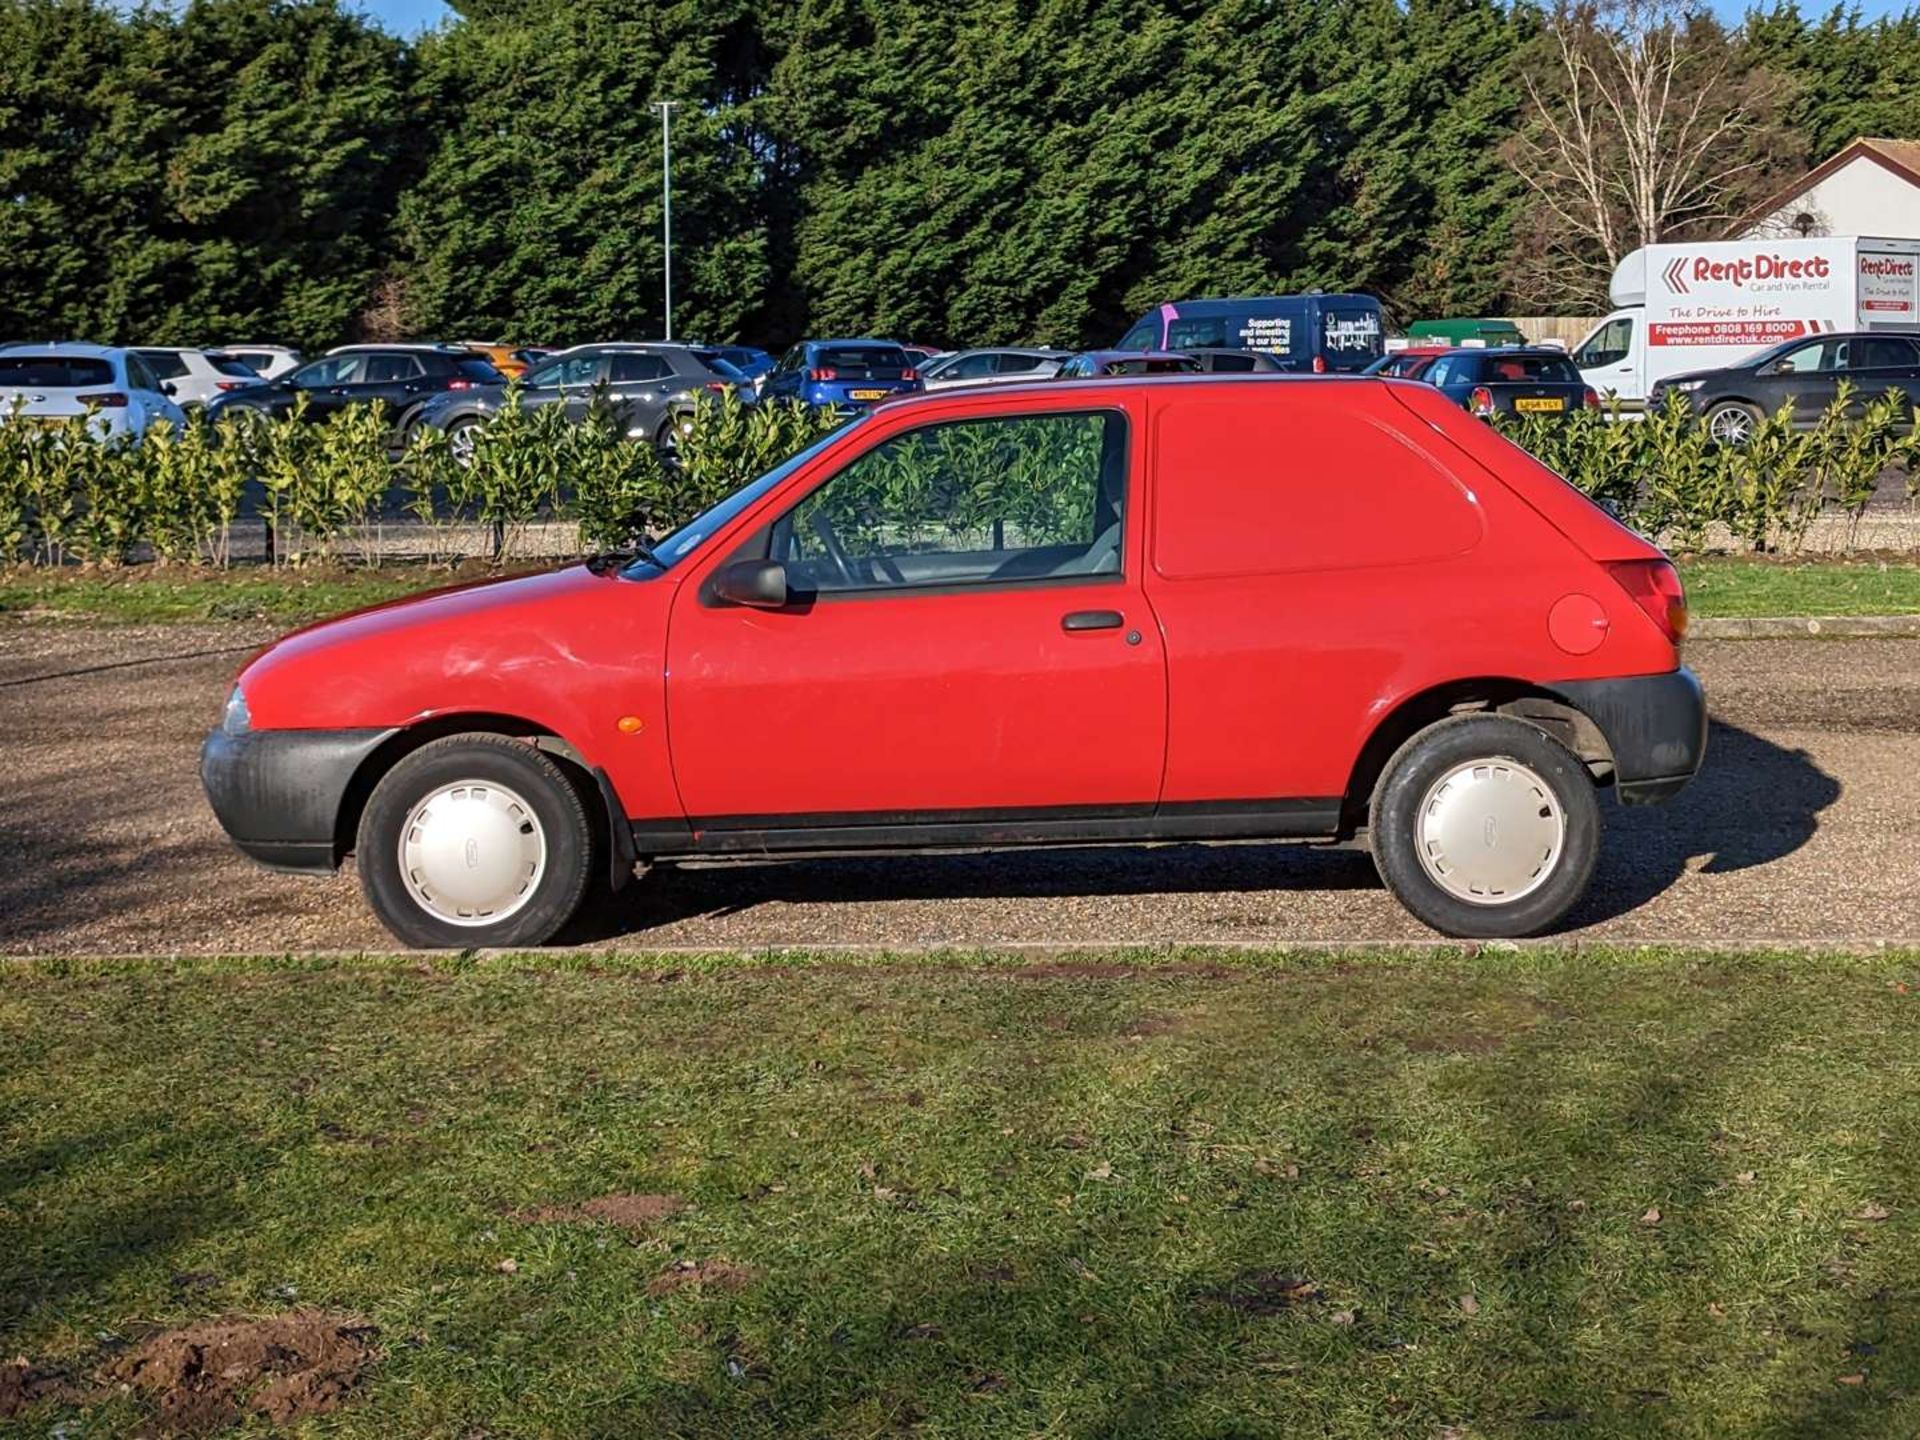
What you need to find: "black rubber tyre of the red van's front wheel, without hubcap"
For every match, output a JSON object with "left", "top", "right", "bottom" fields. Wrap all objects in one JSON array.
[{"left": 355, "top": 735, "right": 595, "bottom": 950}]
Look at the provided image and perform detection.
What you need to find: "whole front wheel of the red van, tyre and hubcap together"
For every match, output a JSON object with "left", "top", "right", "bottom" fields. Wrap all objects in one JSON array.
[{"left": 355, "top": 735, "right": 593, "bottom": 948}]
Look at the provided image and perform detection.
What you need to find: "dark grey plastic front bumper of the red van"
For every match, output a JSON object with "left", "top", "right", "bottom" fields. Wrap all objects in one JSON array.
[{"left": 200, "top": 730, "right": 397, "bottom": 876}]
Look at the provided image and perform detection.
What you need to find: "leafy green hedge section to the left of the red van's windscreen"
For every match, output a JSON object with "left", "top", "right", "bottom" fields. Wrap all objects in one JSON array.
[{"left": 0, "top": 396, "right": 839, "bottom": 564}]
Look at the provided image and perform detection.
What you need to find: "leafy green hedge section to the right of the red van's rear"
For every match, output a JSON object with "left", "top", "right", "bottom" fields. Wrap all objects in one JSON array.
[{"left": 1501, "top": 382, "right": 1920, "bottom": 551}]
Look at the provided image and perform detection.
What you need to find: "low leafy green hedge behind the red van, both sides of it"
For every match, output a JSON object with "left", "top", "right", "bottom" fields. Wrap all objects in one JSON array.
[{"left": 0, "top": 386, "right": 1920, "bottom": 564}]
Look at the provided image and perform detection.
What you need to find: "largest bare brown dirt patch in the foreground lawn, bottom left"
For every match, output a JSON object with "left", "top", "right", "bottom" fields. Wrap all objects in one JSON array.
[{"left": 98, "top": 1309, "right": 378, "bottom": 1434}]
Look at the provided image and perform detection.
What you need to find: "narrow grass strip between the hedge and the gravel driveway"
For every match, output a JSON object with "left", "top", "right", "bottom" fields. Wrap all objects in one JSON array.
[{"left": 11, "top": 557, "right": 1920, "bottom": 624}]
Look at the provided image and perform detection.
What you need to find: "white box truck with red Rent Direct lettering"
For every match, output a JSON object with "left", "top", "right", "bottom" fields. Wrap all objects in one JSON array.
[{"left": 1572, "top": 236, "right": 1920, "bottom": 411}]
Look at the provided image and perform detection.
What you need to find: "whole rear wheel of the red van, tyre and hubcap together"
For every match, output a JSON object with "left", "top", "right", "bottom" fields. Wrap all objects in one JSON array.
[{"left": 1373, "top": 714, "right": 1599, "bottom": 939}]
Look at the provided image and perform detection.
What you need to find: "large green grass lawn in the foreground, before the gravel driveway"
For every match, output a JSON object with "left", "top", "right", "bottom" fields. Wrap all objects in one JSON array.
[{"left": 0, "top": 950, "right": 1920, "bottom": 1440}]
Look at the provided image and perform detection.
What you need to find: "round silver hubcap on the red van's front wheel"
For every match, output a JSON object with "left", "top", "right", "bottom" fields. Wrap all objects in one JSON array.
[{"left": 399, "top": 780, "right": 547, "bottom": 925}]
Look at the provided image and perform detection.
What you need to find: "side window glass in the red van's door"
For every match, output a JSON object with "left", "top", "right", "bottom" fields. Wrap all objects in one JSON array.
[{"left": 770, "top": 411, "right": 1127, "bottom": 595}]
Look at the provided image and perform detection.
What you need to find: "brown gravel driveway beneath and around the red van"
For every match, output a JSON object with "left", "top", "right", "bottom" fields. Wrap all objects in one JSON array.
[{"left": 0, "top": 620, "right": 1920, "bottom": 952}]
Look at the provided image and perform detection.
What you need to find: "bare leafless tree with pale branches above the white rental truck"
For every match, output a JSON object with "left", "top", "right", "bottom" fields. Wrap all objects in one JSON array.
[{"left": 1507, "top": 0, "right": 1799, "bottom": 305}]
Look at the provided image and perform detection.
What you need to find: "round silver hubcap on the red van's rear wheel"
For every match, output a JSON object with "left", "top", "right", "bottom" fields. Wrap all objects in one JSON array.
[{"left": 1415, "top": 758, "right": 1567, "bottom": 904}]
